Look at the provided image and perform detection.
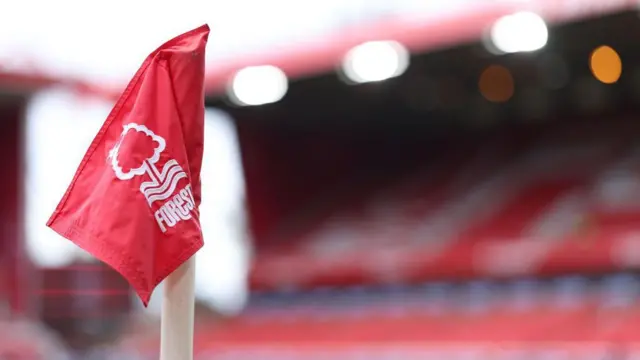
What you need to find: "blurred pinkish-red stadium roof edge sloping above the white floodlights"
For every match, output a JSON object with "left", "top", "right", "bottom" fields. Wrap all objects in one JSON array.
[{"left": 0, "top": 0, "right": 637, "bottom": 97}]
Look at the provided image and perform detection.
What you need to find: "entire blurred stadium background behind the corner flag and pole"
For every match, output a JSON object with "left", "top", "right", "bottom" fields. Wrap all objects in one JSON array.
[{"left": 0, "top": 0, "right": 640, "bottom": 360}]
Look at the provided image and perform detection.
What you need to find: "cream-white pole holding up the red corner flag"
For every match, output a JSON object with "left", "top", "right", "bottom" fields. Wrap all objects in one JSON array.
[{"left": 160, "top": 255, "right": 196, "bottom": 360}]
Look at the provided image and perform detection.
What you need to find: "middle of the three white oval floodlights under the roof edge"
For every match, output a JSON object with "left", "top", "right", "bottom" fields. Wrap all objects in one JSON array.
[{"left": 342, "top": 41, "right": 409, "bottom": 83}]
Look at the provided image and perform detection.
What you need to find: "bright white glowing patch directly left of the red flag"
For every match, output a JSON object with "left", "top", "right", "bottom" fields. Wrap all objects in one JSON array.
[{"left": 24, "top": 89, "right": 111, "bottom": 268}]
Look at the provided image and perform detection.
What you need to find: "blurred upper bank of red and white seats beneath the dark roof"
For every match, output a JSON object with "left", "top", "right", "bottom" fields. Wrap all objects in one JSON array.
[{"left": 246, "top": 119, "right": 640, "bottom": 285}]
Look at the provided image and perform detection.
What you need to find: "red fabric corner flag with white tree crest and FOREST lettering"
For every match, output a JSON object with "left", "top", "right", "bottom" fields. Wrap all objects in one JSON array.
[{"left": 47, "top": 25, "right": 209, "bottom": 306}]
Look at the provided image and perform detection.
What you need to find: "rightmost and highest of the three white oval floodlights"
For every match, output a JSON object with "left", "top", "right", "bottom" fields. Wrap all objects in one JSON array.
[{"left": 491, "top": 12, "right": 549, "bottom": 53}]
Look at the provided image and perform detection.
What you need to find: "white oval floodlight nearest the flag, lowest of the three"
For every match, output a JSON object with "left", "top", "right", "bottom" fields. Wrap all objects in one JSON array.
[{"left": 229, "top": 65, "right": 289, "bottom": 106}]
